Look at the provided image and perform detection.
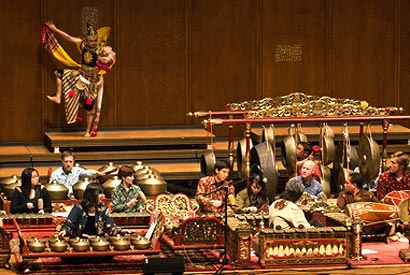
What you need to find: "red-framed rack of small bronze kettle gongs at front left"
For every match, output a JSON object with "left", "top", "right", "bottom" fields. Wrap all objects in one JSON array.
[{"left": 3, "top": 214, "right": 164, "bottom": 270}]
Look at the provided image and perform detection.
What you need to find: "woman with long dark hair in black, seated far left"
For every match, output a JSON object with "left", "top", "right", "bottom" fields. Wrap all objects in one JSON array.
[{"left": 10, "top": 168, "right": 52, "bottom": 214}]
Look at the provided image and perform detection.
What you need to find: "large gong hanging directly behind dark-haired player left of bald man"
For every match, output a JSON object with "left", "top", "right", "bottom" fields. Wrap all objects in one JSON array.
[{"left": 250, "top": 141, "right": 279, "bottom": 202}]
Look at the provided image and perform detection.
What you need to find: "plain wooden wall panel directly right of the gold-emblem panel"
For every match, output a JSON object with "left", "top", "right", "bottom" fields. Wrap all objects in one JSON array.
[{"left": 331, "top": 0, "right": 397, "bottom": 106}]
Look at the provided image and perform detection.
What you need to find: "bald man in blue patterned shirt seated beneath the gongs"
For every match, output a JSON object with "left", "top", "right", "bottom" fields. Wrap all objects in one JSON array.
[{"left": 293, "top": 159, "right": 323, "bottom": 199}]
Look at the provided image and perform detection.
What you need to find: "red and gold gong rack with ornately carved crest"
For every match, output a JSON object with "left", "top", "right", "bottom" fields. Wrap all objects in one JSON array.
[{"left": 187, "top": 92, "right": 410, "bottom": 179}]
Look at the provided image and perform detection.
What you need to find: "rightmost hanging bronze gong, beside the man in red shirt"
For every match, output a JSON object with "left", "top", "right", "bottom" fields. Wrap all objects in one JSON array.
[{"left": 358, "top": 136, "right": 381, "bottom": 187}]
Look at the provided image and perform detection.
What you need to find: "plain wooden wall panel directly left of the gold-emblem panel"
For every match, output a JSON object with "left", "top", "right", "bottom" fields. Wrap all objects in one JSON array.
[{"left": 191, "top": 0, "right": 258, "bottom": 111}]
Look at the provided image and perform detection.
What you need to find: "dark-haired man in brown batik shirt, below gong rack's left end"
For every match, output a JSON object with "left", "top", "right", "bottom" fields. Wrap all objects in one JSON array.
[{"left": 196, "top": 160, "right": 236, "bottom": 215}]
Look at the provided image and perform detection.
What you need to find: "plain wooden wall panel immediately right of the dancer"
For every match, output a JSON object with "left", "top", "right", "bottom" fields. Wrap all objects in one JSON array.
[{"left": 118, "top": 0, "right": 187, "bottom": 126}]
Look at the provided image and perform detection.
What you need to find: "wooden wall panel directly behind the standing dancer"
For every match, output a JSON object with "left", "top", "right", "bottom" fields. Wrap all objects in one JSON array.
[{"left": 41, "top": 0, "right": 117, "bottom": 132}]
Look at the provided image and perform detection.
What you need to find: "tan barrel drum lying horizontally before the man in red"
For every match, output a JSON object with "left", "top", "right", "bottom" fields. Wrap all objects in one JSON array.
[{"left": 346, "top": 202, "right": 398, "bottom": 224}]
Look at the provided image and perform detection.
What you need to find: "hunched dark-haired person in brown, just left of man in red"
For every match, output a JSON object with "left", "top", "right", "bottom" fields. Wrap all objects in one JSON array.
[{"left": 337, "top": 172, "right": 379, "bottom": 210}]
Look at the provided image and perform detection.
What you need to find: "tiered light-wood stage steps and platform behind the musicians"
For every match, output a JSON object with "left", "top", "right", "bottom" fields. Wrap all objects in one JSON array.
[{"left": 0, "top": 124, "right": 410, "bottom": 196}]
